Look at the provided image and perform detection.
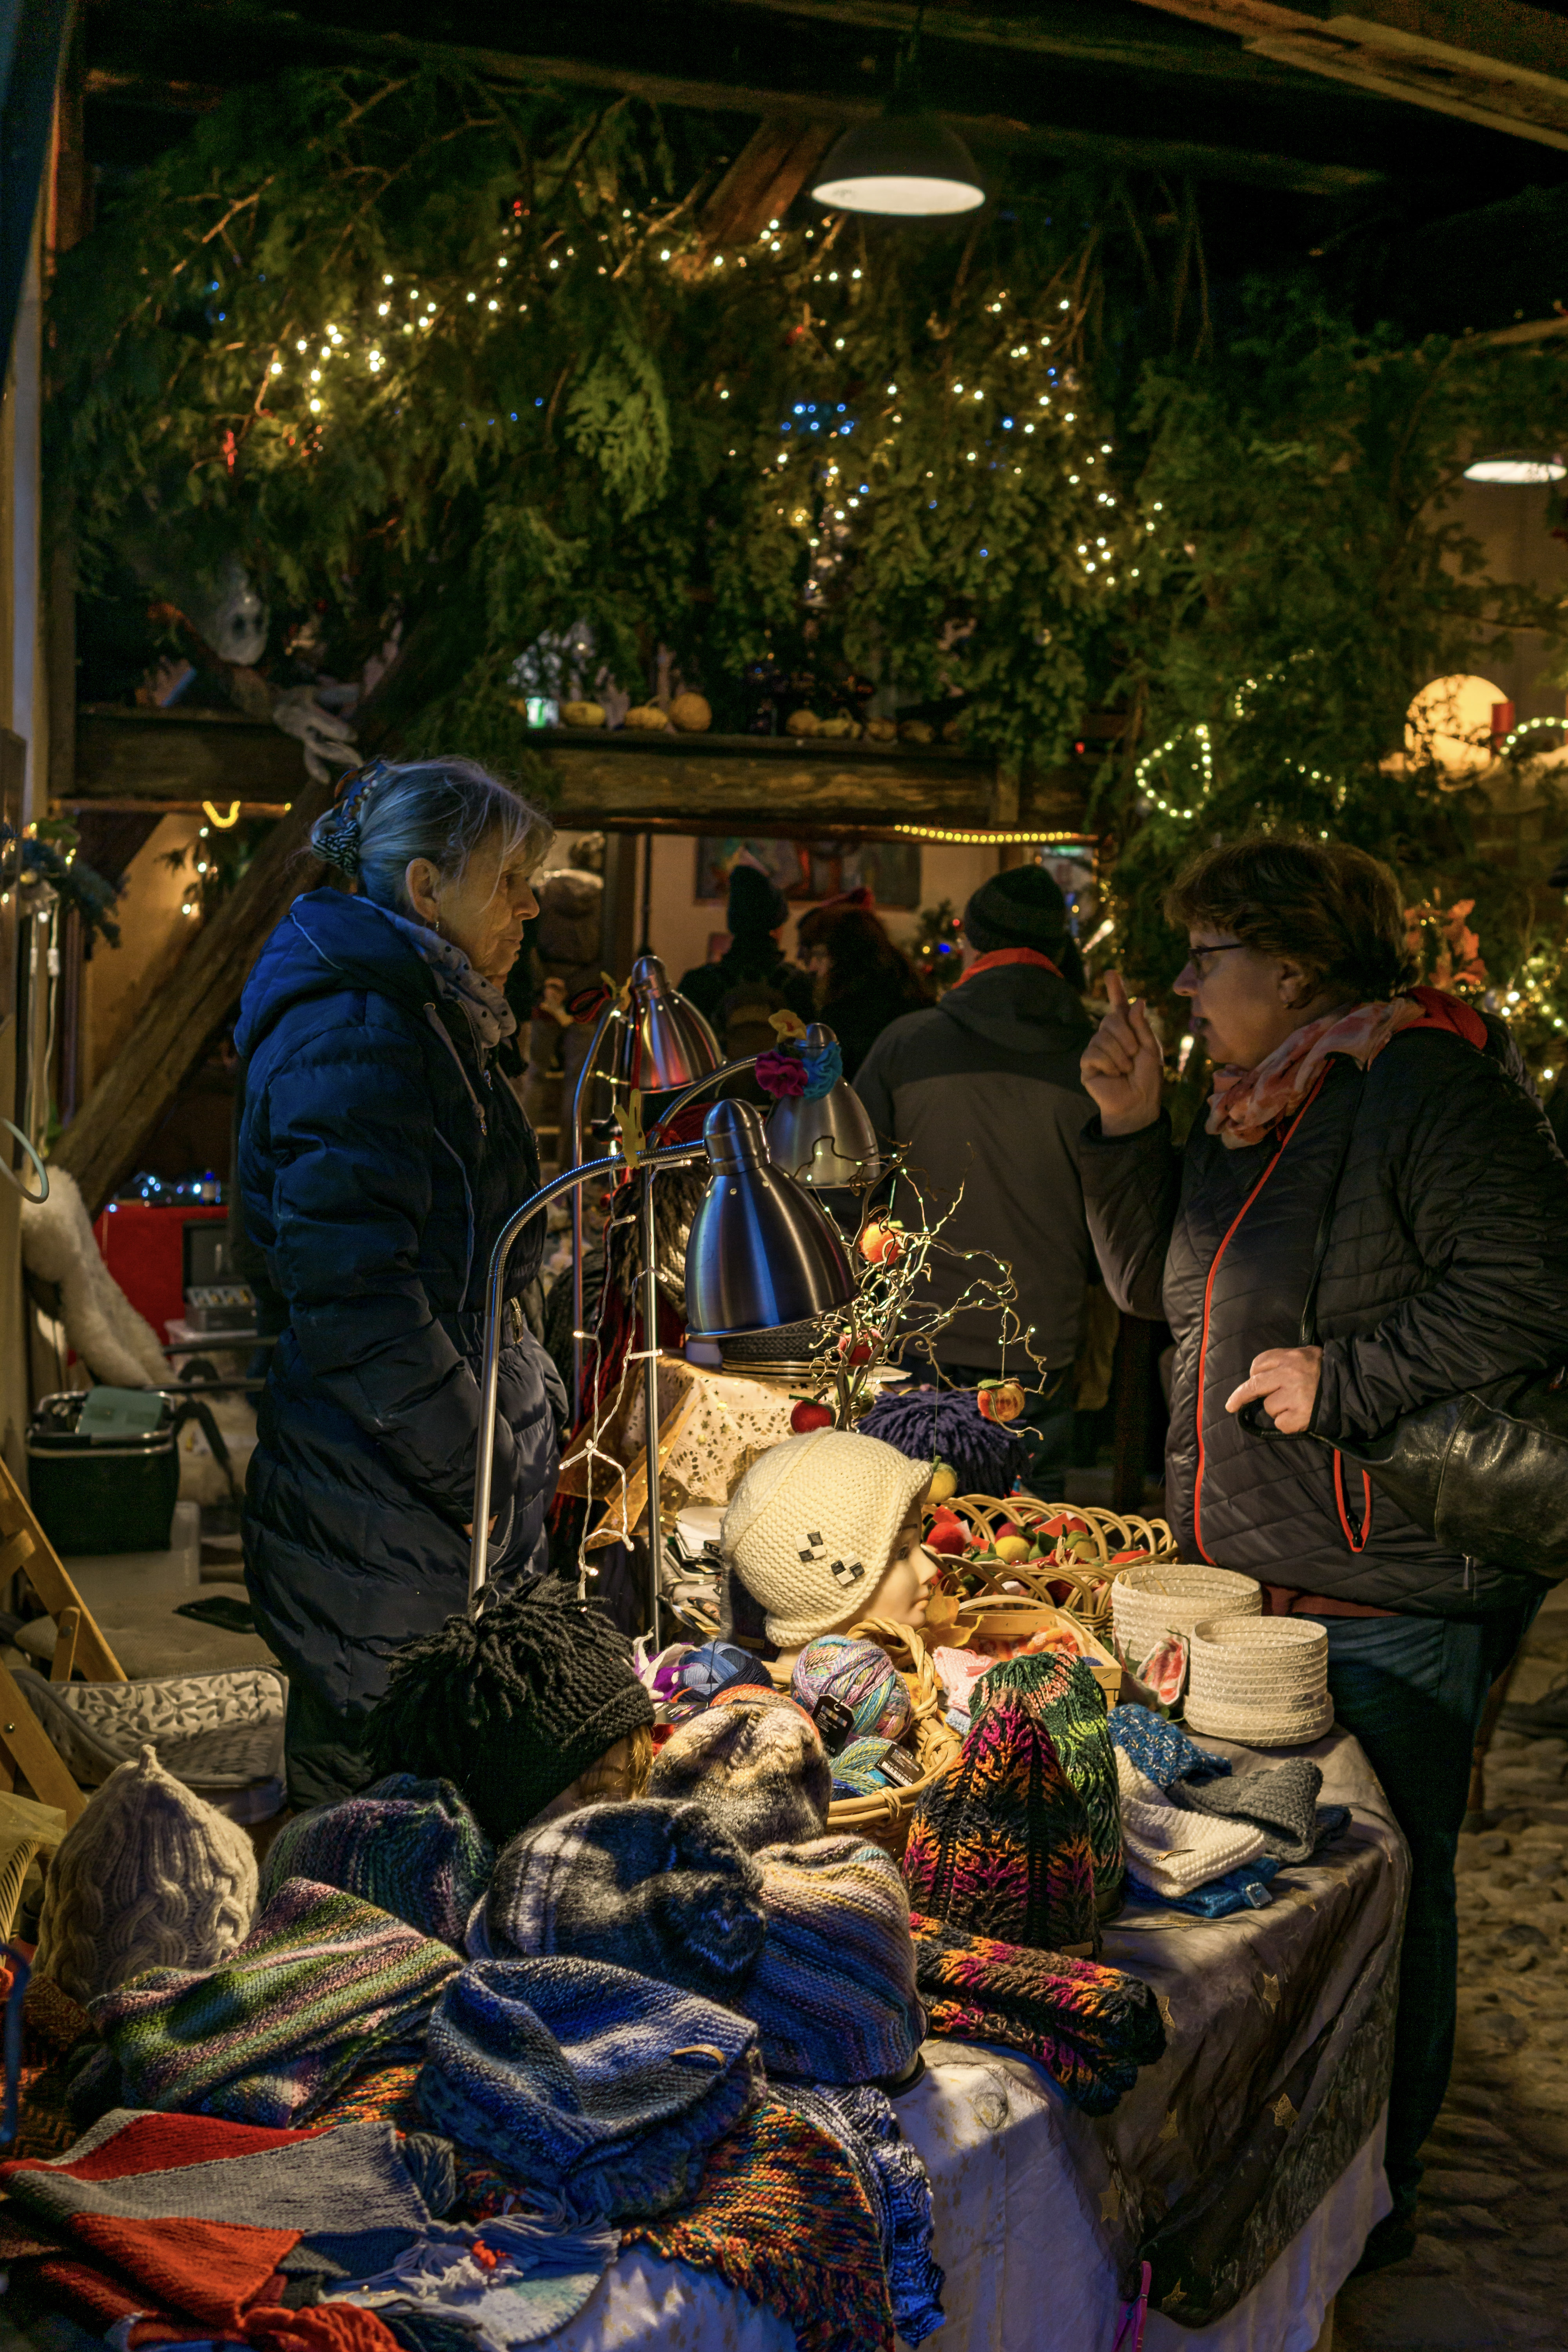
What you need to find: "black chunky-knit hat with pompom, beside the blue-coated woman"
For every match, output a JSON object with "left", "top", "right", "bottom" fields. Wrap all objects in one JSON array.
[{"left": 365, "top": 1592, "right": 653, "bottom": 1846}]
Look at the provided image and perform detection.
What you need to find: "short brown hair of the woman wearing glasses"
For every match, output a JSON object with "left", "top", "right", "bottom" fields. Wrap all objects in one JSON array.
[{"left": 1166, "top": 833, "right": 1415, "bottom": 1000}]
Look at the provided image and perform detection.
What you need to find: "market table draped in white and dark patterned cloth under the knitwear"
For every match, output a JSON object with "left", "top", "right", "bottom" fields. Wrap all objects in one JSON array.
[{"left": 550, "top": 1731, "right": 1408, "bottom": 2352}]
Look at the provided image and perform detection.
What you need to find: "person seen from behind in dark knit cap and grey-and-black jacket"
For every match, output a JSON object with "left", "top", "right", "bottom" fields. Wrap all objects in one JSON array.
[{"left": 853, "top": 866, "right": 1098, "bottom": 1501}]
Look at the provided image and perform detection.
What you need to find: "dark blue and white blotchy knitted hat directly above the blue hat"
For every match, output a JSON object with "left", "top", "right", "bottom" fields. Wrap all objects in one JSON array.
[{"left": 479, "top": 1797, "right": 764, "bottom": 2002}]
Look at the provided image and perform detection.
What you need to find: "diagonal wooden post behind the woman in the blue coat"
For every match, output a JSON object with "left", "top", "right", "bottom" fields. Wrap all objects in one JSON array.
[{"left": 54, "top": 783, "right": 334, "bottom": 1216}]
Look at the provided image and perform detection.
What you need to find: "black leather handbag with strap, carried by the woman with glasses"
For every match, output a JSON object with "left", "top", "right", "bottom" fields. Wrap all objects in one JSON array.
[{"left": 1241, "top": 1068, "right": 1568, "bottom": 1583}]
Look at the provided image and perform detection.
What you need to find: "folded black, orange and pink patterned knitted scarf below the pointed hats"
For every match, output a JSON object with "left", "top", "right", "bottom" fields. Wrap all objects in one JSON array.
[{"left": 910, "top": 1912, "right": 1166, "bottom": 2114}]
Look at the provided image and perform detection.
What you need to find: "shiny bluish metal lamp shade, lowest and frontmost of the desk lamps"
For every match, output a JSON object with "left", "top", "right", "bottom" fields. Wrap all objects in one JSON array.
[{"left": 686, "top": 1103, "right": 856, "bottom": 1338}]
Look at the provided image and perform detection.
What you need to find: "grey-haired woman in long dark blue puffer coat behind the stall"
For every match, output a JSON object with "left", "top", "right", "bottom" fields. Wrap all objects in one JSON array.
[{"left": 235, "top": 760, "right": 566, "bottom": 1804}]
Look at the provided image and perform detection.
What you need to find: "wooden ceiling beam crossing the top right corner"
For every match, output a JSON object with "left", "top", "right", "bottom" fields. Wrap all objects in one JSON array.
[{"left": 1140, "top": 0, "right": 1568, "bottom": 148}]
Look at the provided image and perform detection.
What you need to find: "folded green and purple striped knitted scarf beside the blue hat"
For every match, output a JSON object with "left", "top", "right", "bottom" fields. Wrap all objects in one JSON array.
[{"left": 89, "top": 1879, "right": 458, "bottom": 2124}]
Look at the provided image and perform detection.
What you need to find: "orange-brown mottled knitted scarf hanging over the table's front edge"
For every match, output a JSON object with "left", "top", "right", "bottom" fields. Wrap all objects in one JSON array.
[{"left": 623, "top": 2098, "right": 893, "bottom": 2352}]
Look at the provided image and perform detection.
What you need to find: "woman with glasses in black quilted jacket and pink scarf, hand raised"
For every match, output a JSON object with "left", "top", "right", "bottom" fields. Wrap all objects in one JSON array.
[{"left": 1079, "top": 837, "right": 1568, "bottom": 2270}]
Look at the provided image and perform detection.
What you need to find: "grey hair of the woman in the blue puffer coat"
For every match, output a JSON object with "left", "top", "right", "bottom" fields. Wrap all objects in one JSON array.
[{"left": 310, "top": 760, "right": 555, "bottom": 915}]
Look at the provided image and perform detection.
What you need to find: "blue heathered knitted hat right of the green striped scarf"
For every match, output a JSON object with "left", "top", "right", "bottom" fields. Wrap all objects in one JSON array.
[{"left": 418, "top": 1957, "right": 764, "bottom": 2220}]
